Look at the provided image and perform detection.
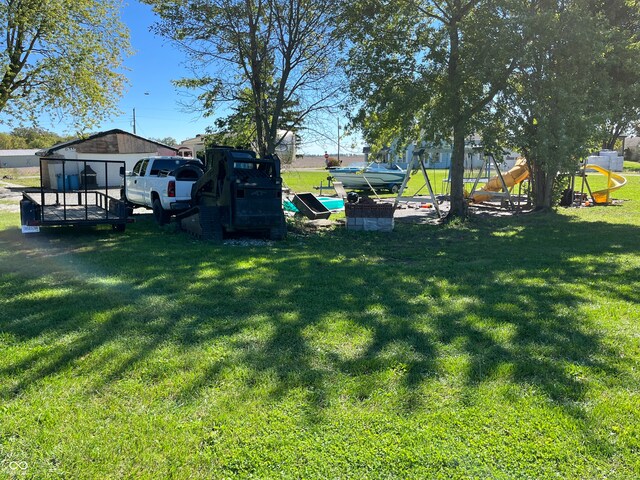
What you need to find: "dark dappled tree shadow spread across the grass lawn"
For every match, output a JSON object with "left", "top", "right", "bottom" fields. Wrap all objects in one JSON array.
[{"left": 0, "top": 216, "right": 640, "bottom": 428}]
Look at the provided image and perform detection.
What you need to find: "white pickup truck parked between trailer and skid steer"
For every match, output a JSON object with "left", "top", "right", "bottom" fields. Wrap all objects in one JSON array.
[{"left": 121, "top": 157, "right": 203, "bottom": 225}]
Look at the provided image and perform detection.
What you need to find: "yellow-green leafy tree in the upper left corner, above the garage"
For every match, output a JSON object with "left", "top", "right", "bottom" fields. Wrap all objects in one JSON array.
[{"left": 0, "top": 0, "right": 129, "bottom": 130}]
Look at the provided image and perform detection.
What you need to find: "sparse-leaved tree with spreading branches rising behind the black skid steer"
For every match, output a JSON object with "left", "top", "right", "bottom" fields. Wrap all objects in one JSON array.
[{"left": 145, "top": 0, "right": 340, "bottom": 155}]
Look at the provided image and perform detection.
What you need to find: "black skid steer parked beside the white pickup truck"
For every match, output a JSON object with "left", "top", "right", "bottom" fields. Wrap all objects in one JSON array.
[{"left": 179, "top": 146, "right": 287, "bottom": 241}]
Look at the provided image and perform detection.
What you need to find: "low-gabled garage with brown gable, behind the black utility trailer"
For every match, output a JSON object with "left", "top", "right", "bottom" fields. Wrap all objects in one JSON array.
[{"left": 37, "top": 129, "right": 178, "bottom": 187}]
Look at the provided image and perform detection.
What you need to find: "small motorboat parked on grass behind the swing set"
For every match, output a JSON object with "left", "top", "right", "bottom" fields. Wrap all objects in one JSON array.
[{"left": 329, "top": 162, "right": 407, "bottom": 193}]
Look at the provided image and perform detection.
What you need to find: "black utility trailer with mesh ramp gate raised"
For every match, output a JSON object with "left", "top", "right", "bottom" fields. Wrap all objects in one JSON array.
[{"left": 20, "top": 158, "right": 128, "bottom": 232}]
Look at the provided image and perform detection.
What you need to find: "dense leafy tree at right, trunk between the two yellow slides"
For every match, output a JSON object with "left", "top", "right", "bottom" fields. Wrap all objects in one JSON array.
[{"left": 496, "top": 0, "right": 640, "bottom": 210}]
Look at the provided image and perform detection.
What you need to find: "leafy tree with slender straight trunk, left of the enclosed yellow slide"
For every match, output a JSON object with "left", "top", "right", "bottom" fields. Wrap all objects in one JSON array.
[{"left": 344, "top": 0, "right": 523, "bottom": 218}]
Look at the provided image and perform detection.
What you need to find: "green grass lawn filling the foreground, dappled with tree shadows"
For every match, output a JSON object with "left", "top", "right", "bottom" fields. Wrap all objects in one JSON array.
[{"left": 0, "top": 172, "right": 640, "bottom": 479}]
